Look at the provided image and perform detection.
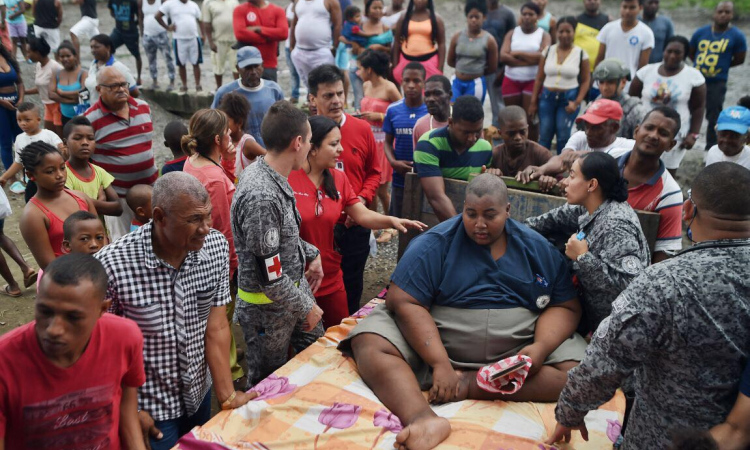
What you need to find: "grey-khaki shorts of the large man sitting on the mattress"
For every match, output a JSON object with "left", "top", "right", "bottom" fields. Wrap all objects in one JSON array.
[{"left": 339, "top": 304, "right": 586, "bottom": 390}]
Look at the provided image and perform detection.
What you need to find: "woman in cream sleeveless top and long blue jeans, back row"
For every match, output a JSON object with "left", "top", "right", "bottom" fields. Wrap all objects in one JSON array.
[{"left": 528, "top": 16, "right": 591, "bottom": 154}]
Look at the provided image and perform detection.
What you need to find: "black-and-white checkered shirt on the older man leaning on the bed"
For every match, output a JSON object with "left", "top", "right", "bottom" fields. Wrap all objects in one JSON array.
[{"left": 96, "top": 223, "right": 231, "bottom": 420}]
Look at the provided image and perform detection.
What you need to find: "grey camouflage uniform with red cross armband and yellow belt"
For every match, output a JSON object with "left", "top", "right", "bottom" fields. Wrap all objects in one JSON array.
[{"left": 232, "top": 158, "right": 323, "bottom": 386}]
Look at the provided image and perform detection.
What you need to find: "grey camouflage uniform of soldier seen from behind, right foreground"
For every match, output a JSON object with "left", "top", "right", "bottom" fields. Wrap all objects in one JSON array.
[{"left": 555, "top": 239, "right": 750, "bottom": 449}]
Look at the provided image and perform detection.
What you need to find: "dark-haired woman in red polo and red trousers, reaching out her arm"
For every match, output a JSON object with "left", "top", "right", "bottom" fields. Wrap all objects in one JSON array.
[{"left": 289, "top": 116, "right": 427, "bottom": 327}]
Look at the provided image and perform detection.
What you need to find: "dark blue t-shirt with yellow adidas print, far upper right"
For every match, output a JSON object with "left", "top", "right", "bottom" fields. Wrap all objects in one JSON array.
[{"left": 690, "top": 25, "right": 747, "bottom": 83}]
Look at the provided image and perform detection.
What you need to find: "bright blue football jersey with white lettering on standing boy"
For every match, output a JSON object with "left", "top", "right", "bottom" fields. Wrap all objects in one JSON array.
[{"left": 383, "top": 99, "right": 427, "bottom": 187}]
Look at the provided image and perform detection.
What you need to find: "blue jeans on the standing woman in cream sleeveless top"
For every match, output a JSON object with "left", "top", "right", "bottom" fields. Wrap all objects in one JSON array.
[{"left": 539, "top": 88, "right": 580, "bottom": 153}]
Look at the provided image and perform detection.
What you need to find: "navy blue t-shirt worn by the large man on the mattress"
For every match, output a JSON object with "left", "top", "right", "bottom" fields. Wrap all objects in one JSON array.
[{"left": 391, "top": 214, "right": 576, "bottom": 312}]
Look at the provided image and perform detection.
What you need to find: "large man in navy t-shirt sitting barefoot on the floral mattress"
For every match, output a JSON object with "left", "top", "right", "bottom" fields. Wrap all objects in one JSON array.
[{"left": 341, "top": 174, "right": 586, "bottom": 450}]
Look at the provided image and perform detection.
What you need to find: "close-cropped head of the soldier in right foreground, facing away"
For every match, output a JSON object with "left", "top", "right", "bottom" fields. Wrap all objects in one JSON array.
[{"left": 692, "top": 162, "right": 750, "bottom": 221}]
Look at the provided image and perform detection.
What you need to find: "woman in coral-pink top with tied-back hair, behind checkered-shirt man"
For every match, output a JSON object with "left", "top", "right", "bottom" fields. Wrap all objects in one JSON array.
[{"left": 182, "top": 109, "right": 243, "bottom": 380}]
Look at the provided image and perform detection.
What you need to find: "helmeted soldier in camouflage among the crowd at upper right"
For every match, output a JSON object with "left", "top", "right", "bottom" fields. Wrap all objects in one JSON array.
[{"left": 594, "top": 58, "right": 649, "bottom": 139}]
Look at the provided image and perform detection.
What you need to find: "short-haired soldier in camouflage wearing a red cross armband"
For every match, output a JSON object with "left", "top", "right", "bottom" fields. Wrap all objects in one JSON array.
[{"left": 232, "top": 101, "right": 323, "bottom": 387}]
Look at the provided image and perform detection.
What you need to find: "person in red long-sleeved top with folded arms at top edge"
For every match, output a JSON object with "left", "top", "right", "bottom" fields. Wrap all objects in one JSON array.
[{"left": 232, "top": 0, "right": 289, "bottom": 81}]
